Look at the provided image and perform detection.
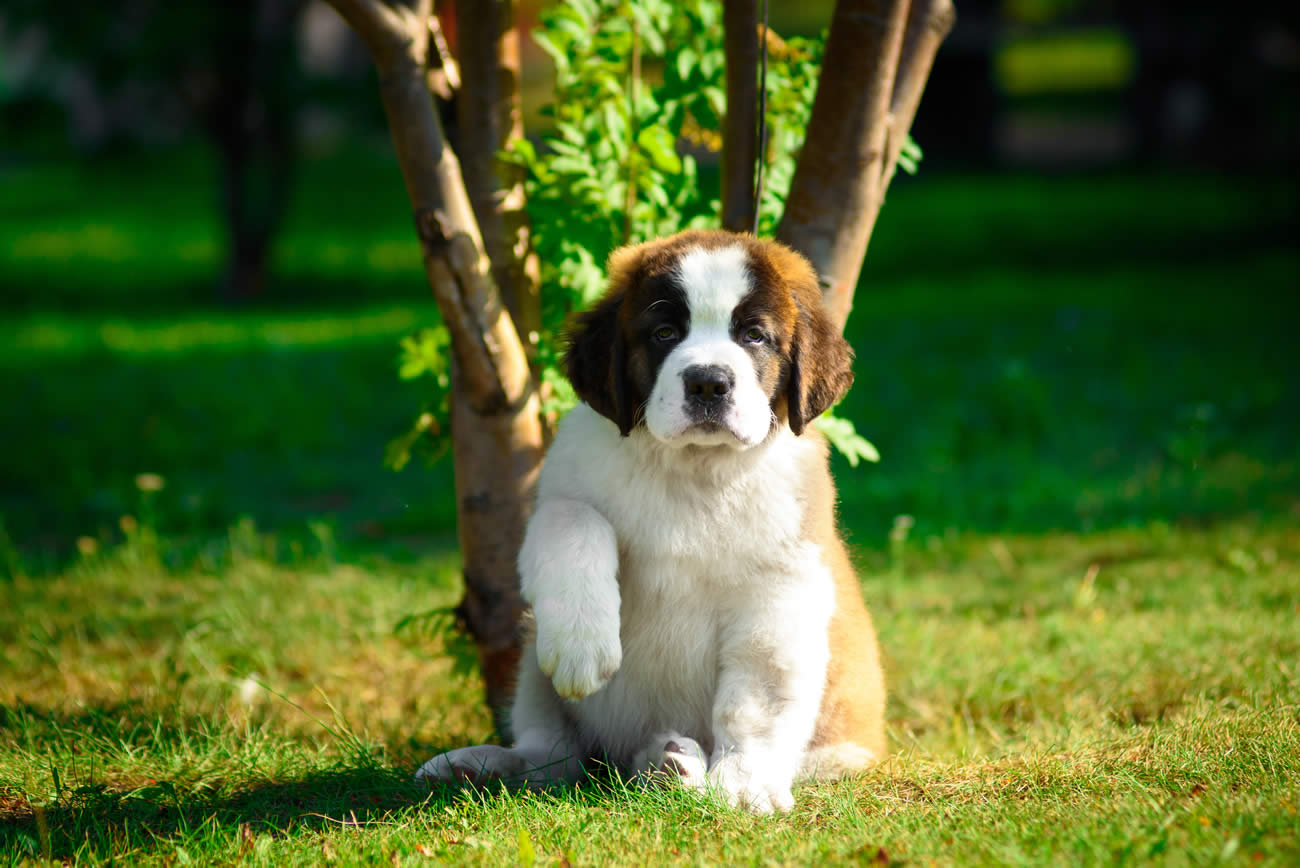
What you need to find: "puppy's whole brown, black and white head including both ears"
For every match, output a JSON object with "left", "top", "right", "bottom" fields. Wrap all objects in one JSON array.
[{"left": 566, "top": 231, "right": 853, "bottom": 448}]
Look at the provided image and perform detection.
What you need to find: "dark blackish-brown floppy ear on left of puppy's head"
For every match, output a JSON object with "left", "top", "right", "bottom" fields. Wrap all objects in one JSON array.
[{"left": 564, "top": 292, "right": 636, "bottom": 437}]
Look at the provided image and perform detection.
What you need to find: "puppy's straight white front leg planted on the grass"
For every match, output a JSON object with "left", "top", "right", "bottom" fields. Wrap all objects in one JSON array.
[{"left": 709, "top": 586, "right": 833, "bottom": 813}]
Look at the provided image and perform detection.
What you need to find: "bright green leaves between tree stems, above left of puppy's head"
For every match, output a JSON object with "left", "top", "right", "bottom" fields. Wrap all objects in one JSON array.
[{"left": 504, "top": 0, "right": 725, "bottom": 379}]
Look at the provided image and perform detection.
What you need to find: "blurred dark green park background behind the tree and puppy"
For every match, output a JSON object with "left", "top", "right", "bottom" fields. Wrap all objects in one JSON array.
[{"left": 0, "top": 0, "right": 1300, "bottom": 573}]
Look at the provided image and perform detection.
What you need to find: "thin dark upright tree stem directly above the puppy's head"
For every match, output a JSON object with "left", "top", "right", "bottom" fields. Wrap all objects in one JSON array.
[{"left": 722, "top": 0, "right": 758, "bottom": 233}]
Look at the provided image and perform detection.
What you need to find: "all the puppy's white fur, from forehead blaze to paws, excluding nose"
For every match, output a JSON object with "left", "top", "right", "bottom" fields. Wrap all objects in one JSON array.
[{"left": 417, "top": 240, "right": 835, "bottom": 813}]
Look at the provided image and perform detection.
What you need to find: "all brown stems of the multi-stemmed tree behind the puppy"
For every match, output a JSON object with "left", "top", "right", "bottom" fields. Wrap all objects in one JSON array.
[{"left": 330, "top": 0, "right": 952, "bottom": 738}]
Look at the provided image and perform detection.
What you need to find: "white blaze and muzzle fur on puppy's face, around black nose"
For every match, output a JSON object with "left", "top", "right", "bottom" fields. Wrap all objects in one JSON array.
[{"left": 646, "top": 246, "right": 772, "bottom": 448}]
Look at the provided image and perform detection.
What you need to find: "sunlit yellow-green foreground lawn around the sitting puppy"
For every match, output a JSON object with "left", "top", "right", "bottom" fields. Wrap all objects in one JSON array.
[{"left": 0, "top": 522, "right": 1300, "bottom": 865}]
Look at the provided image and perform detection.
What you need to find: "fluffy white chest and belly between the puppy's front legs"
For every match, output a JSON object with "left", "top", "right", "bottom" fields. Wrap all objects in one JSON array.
[{"left": 579, "top": 446, "right": 807, "bottom": 763}]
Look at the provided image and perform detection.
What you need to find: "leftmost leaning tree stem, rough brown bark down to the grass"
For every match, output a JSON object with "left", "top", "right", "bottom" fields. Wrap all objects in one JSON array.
[{"left": 330, "top": 0, "right": 542, "bottom": 738}]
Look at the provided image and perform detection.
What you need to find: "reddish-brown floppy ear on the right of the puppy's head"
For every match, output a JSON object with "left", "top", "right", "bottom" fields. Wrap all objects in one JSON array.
[{"left": 785, "top": 298, "right": 853, "bottom": 434}]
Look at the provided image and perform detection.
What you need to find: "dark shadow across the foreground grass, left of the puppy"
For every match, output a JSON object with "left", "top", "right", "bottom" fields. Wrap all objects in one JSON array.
[{"left": 0, "top": 703, "right": 612, "bottom": 862}]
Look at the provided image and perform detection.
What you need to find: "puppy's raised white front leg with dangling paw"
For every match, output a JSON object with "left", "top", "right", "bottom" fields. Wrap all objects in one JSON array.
[{"left": 519, "top": 498, "right": 623, "bottom": 699}]
